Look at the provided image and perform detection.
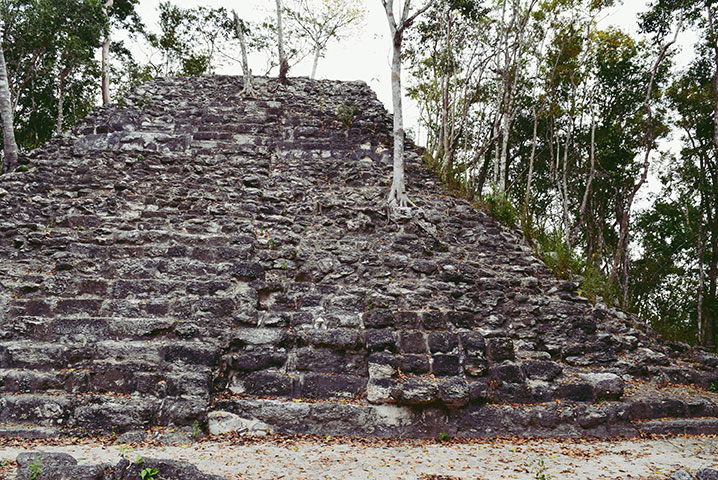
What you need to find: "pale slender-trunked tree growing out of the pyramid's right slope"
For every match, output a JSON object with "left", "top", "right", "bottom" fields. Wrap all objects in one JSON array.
[{"left": 381, "top": 0, "right": 434, "bottom": 208}]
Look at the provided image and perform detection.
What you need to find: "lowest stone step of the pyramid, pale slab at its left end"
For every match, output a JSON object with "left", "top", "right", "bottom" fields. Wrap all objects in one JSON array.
[{"left": 208, "top": 398, "right": 718, "bottom": 438}]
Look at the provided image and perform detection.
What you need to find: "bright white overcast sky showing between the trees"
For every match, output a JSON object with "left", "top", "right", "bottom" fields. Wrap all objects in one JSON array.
[{"left": 129, "top": 0, "right": 692, "bottom": 143}]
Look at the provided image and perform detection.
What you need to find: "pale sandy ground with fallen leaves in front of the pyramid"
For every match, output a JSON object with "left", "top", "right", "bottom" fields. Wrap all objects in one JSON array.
[{"left": 0, "top": 436, "right": 718, "bottom": 480}]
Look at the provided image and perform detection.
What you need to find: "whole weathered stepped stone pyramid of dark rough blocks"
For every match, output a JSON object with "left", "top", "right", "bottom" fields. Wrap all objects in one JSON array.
[{"left": 0, "top": 76, "right": 718, "bottom": 437}]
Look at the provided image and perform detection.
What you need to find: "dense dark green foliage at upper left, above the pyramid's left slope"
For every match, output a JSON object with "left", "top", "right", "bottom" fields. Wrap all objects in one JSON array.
[{"left": 0, "top": 0, "right": 107, "bottom": 150}]
